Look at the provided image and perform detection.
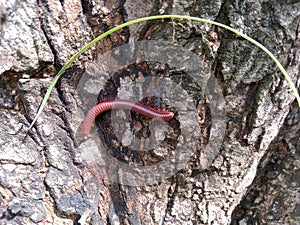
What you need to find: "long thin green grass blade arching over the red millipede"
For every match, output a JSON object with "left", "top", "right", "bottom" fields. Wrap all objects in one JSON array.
[{"left": 29, "top": 15, "right": 300, "bottom": 129}]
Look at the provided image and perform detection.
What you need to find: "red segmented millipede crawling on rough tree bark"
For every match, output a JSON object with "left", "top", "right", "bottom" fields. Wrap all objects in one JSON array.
[{"left": 81, "top": 99, "right": 174, "bottom": 136}]
